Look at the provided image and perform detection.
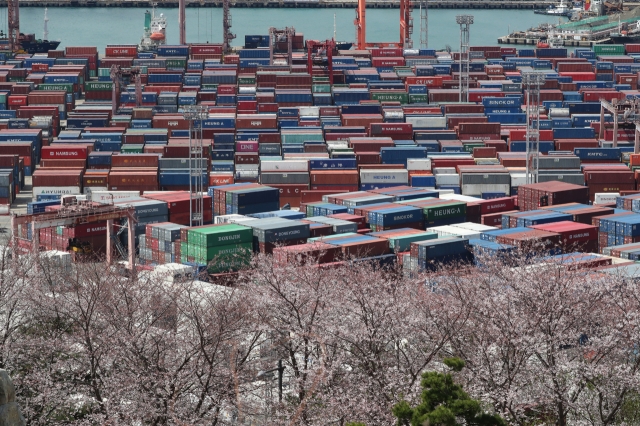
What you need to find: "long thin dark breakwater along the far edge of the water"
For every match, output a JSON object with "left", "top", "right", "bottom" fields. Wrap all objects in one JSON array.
[{"left": 0, "top": 0, "right": 576, "bottom": 9}]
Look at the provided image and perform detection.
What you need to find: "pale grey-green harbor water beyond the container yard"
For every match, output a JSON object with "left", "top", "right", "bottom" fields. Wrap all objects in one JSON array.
[{"left": 7, "top": 7, "right": 566, "bottom": 51}]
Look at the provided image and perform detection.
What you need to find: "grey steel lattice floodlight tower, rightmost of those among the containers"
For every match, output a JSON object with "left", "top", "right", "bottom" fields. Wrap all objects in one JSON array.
[{"left": 522, "top": 72, "right": 546, "bottom": 184}]
